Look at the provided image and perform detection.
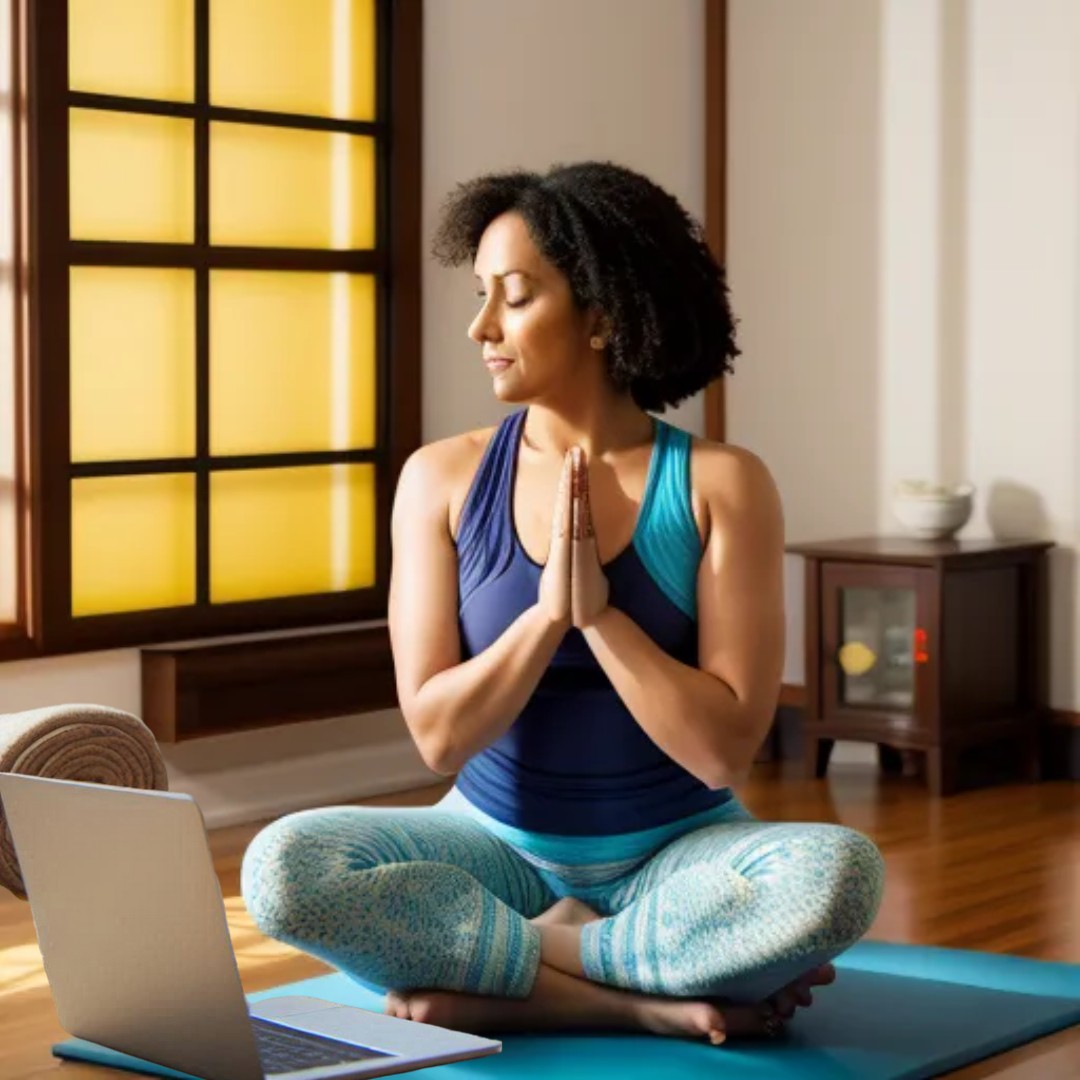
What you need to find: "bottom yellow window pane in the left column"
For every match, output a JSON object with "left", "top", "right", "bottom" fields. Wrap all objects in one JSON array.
[{"left": 71, "top": 475, "right": 195, "bottom": 617}]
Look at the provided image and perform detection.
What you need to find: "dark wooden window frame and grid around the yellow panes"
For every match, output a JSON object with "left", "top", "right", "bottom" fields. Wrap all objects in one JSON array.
[{"left": 0, "top": 0, "right": 422, "bottom": 660}]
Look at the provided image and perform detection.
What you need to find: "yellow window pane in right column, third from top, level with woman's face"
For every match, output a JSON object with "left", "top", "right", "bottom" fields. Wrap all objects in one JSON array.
[{"left": 210, "top": 270, "right": 376, "bottom": 455}]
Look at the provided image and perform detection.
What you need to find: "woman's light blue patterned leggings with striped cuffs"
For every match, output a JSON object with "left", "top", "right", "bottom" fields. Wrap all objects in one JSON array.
[{"left": 241, "top": 786, "right": 883, "bottom": 1002}]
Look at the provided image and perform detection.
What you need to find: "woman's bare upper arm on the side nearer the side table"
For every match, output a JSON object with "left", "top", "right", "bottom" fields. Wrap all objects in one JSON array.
[{"left": 698, "top": 446, "right": 785, "bottom": 751}]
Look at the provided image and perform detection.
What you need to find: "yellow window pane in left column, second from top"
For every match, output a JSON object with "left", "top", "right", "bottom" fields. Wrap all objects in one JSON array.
[{"left": 70, "top": 109, "right": 194, "bottom": 243}]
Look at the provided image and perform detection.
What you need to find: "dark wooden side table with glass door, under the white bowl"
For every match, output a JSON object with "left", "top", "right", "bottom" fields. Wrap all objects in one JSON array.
[{"left": 787, "top": 537, "right": 1053, "bottom": 795}]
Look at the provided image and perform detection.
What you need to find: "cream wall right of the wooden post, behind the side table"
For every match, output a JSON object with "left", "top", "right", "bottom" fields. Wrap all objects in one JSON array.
[{"left": 728, "top": 0, "right": 1080, "bottom": 710}]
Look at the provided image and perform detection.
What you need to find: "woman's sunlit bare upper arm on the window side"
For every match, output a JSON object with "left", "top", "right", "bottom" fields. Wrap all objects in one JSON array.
[{"left": 389, "top": 442, "right": 461, "bottom": 745}]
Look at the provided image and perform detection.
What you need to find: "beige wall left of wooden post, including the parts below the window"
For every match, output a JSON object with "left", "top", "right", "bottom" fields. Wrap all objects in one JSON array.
[{"left": 0, "top": 0, "right": 704, "bottom": 824}]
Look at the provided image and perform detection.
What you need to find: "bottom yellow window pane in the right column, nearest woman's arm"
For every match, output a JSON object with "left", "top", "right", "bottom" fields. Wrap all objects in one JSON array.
[{"left": 210, "top": 464, "right": 375, "bottom": 604}]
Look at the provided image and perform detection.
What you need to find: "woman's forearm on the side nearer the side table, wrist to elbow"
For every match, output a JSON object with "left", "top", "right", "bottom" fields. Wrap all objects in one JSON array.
[{"left": 582, "top": 607, "right": 761, "bottom": 788}]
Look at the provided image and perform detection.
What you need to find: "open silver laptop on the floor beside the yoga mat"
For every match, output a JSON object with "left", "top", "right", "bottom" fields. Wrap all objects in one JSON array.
[{"left": 0, "top": 772, "right": 502, "bottom": 1080}]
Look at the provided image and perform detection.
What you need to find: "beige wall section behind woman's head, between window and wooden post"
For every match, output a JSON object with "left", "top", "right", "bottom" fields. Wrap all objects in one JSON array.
[{"left": 423, "top": 0, "right": 705, "bottom": 440}]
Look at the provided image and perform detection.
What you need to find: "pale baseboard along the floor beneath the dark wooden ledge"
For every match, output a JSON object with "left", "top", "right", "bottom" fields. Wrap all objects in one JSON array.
[{"left": 168, "top": 738, "right": 442, "bottom": 828}]
